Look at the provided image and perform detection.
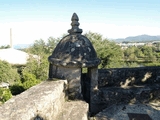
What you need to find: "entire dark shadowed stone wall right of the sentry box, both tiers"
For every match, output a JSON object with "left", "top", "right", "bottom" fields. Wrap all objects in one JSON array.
[{"left": 90, "top": 67, "right": 160, "bottom": 114}]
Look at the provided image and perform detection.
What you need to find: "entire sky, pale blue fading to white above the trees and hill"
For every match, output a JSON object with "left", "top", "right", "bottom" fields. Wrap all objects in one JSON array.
[{"left": 0, "top": 0, "right": 160, "bottom": 46}]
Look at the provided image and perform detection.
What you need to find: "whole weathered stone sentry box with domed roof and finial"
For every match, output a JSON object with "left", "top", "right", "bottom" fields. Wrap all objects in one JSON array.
[{"left": 48, "top": 13, "right": 100, "bottom": 102}]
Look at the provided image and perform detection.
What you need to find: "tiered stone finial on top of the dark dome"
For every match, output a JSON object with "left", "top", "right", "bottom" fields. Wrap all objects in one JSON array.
[{"left": 68, "top": 13, "right": 82, "bottom": 34}]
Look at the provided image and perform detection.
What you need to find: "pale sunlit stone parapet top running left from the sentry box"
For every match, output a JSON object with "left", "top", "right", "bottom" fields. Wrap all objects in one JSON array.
[{"left": 0, "top": 80, "right": 67, "bottom": 120}]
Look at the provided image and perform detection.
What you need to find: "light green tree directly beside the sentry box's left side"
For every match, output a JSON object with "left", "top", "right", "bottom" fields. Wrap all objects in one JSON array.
[{"left": 23, "top": 37, "right": 60, "bottom": 80}]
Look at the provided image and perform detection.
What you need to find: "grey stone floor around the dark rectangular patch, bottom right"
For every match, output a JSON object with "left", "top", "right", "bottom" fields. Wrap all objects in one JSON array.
[{"left": 94, "top": 103, "right": 160, "bottom": 120}]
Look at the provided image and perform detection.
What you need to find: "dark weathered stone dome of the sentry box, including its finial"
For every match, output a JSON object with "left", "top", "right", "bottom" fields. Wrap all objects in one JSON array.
[{"left": 48, "top": 13, "right": 100, "bottom": 67}]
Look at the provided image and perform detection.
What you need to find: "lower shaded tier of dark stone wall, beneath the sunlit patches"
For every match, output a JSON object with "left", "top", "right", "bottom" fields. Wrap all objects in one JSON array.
[{"left": 90, "top": 84, "right": 160, "bottom": 116}]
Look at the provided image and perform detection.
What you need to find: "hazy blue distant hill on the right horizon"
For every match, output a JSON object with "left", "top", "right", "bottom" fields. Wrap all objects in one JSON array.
[{"left": 114, "top": 35, "right": 160, "bottom": 42}]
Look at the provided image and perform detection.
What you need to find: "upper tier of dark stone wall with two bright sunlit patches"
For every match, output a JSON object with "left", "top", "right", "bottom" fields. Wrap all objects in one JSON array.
[{"left": 98, "top": 67, "right": 160, "bottom": 88}]
